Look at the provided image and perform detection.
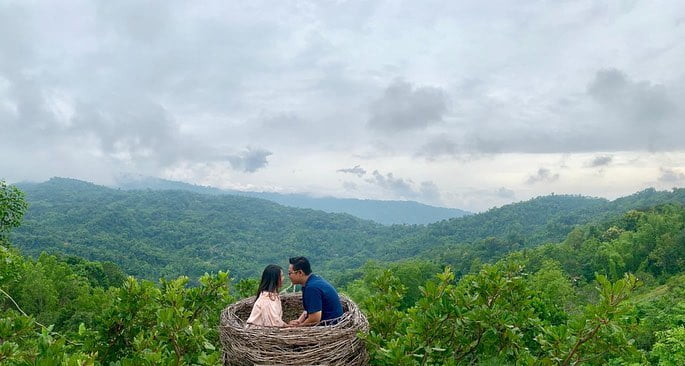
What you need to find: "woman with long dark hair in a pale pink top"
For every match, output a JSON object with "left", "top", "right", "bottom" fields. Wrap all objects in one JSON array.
[{"left": 247, "top": 264, "right": 286, "bottom": 327}]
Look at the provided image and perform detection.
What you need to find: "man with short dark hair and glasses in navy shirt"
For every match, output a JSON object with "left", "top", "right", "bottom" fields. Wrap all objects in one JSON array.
[{"left": 288, "top": 257, "right": 342, "bottom": 327}]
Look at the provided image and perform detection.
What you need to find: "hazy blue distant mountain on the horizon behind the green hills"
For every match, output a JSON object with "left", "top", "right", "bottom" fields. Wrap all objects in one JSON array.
[{"left": 116, "top": 176, "right": 471, "bottom": 225}]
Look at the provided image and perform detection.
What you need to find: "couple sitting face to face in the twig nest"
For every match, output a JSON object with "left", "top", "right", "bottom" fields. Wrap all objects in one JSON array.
[{"left": 247, "top": 257, "right": 342, "bottom": 327}]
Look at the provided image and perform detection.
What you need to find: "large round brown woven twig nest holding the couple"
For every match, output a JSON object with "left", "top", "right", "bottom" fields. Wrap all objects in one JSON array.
[{"left": 219, "top": 293, "right": 369, "bottom": 365}]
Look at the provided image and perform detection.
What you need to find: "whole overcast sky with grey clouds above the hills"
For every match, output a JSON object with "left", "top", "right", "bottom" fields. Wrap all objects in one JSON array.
[{"left": 0, "top": 0, "right": 685, "bottom": 211}]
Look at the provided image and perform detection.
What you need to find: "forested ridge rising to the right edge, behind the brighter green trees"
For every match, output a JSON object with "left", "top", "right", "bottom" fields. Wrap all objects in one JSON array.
[{"left": 384, "top": 188, "right": 685, "bottom": 273}]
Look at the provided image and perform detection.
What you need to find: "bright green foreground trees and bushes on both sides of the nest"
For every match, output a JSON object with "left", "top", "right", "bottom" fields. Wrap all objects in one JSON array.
[{"left": 0, "top": 183, "right": 685, "bottom": 365}]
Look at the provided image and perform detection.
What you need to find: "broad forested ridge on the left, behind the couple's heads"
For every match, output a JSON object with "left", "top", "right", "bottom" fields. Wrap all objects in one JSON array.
[{"left": 13, "top": 178, "right": 414, "bottom": 279}]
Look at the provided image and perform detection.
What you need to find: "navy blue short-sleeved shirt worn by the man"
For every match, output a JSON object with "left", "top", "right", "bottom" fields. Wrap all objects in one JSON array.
[{"left": 302, "top": 274, "right": 342, "bottom": 322}]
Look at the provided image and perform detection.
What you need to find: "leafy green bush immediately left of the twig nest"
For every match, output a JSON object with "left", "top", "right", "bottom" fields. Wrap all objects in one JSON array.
[{"left": 87, "top": 272, "right": 231, "bottom": 365}]
